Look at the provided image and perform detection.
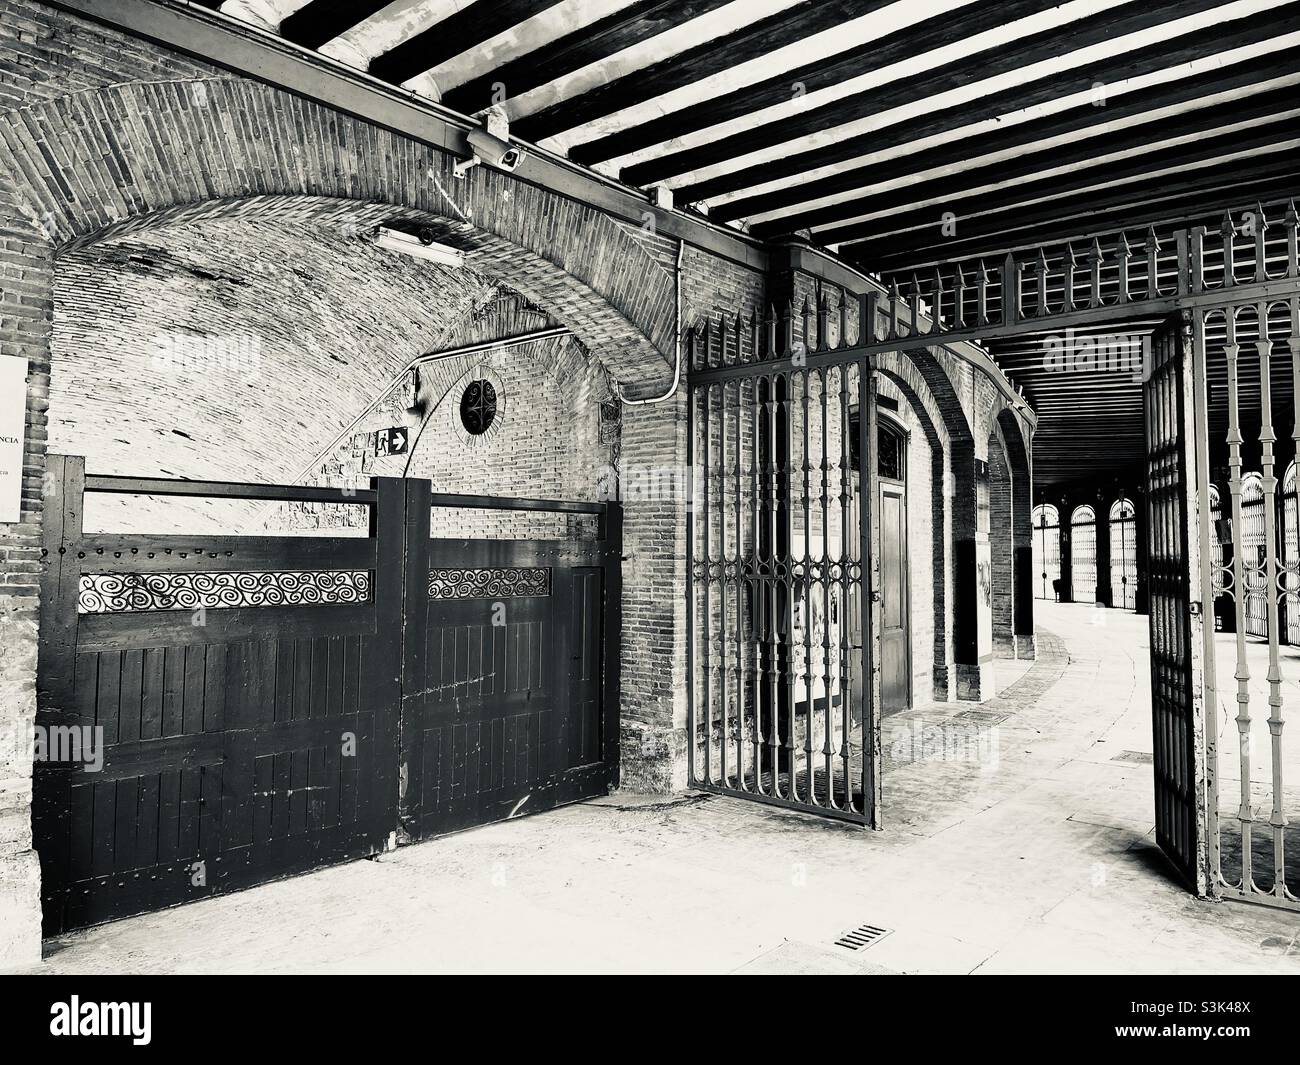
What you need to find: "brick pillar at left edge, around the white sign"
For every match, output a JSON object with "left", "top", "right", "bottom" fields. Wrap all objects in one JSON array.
[{"left": 0, "top": 221, "right": 53, "bottom": 969}]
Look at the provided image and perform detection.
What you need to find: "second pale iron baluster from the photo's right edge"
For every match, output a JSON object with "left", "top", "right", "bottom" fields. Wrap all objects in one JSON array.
[{"left": 1256, "top": 301, "right": 1287, "bottom": 899}]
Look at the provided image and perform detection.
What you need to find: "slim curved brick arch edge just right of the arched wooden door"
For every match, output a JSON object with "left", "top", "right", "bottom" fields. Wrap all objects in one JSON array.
[{"left": 867, "top": 351, "right": 953, "bottom": 702}]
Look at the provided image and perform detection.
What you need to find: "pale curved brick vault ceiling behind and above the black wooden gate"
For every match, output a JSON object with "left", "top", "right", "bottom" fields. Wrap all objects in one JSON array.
[{"left": 49, "top": 218, "right": 497, "bottom": 484}]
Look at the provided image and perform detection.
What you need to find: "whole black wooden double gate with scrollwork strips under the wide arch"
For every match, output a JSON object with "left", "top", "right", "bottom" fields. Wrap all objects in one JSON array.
[{"left": 33, "top": 455, "right": 620, "bottom": 934}]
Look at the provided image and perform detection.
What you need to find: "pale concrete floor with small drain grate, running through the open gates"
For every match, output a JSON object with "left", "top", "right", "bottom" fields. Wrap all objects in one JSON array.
[{"left": 20, "top": 602, "right": 1300, "bottom": 974}]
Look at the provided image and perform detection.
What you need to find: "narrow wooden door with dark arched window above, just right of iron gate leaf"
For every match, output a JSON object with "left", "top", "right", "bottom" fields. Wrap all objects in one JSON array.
[{"left": 876, "top": 417, "right": 911, "bottom": 713}]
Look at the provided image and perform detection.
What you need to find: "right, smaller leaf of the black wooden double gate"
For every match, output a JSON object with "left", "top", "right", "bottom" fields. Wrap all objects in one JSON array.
[{"left": 402, "top": 512, "right": 620, "bottom": 839}]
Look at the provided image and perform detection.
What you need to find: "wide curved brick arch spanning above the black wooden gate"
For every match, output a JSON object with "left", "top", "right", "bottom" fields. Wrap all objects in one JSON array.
[{"left": 0, "top": 78, "right": 676, "bottom": 390}]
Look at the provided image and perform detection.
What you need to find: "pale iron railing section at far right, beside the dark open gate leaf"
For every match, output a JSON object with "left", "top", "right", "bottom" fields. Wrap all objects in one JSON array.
[{"left": 1195, "top": 289, "right": 1300, "bottom": 909}]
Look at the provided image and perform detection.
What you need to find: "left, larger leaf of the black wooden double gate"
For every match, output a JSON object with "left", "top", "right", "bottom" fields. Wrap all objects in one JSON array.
[{"left": 33, "top": 456, "right": 403, "bottom": 934}]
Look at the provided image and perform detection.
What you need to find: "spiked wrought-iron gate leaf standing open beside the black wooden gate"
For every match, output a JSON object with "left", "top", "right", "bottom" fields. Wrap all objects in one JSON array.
[{"left": 688, "top": 304, "right": 880, "bottom": 826}]
